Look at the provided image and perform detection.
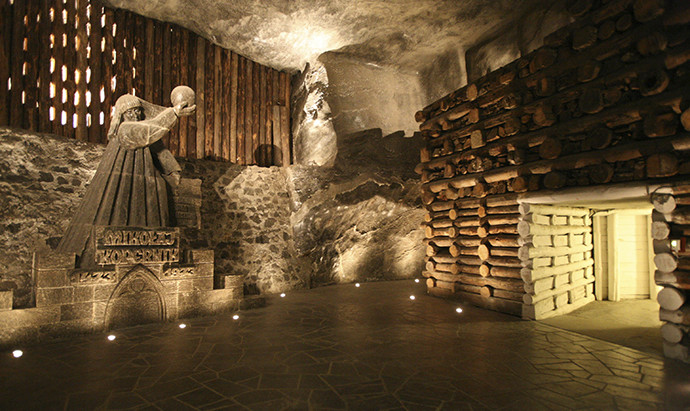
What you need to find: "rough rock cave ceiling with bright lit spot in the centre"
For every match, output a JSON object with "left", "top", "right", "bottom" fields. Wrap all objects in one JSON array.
[{"left": 106, "top": 0, "right": 552, "bottom": 72}]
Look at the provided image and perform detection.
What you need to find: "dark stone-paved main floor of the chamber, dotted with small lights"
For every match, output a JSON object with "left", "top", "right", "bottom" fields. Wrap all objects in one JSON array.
[{"left": 0, "top": 280, "right": 690, "bottom": 410}]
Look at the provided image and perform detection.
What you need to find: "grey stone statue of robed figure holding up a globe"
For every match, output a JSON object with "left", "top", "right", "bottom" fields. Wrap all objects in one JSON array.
[{"left": 57, "top": 86, "right": 196, "bottom": 267}]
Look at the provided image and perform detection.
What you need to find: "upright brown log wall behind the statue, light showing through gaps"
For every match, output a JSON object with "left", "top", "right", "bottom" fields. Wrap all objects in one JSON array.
[{"left": 0, "top": 0, "right": 291, "bottom": 166}]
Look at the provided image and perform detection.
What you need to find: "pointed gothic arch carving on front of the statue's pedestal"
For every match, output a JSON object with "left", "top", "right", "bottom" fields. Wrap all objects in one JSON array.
[{"left": 105, "top": 265, "right": 167, "bottom": 329}]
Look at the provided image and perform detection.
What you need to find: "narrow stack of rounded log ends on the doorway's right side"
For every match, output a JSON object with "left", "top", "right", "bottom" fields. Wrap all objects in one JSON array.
[{"left": 652, "top": 185, "right": 690, "bottom": 361}]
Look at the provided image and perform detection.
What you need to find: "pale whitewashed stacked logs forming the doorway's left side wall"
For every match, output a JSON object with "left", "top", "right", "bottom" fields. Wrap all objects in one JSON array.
[{"left": 518, "top": 204, "right": 594, "bottom": 320}]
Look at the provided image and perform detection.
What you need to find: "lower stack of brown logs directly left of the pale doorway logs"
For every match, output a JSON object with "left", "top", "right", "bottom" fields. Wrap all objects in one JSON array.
[{"left": 423, "top": 194, "right": 524, "bottom": 315}]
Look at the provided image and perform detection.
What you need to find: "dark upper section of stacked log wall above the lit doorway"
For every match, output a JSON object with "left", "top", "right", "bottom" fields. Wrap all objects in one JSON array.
[{"left": 416, "top": 0, "right": 690, "bottom": 197}]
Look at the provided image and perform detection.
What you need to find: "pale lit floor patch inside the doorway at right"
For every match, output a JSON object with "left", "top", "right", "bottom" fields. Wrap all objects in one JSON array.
[{"left": 542, "top": 300, "right": 664, "bottom": 355}]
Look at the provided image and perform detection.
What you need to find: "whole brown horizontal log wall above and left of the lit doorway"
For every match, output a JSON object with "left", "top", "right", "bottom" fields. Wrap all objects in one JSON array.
[{"left": 415, "top": 0, "right": 690, "bottom": 328}]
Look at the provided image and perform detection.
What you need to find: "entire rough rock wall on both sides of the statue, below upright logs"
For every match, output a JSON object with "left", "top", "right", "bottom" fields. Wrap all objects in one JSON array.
[{"left": 0, "top": 129, "right": 423, "bottom": 308}]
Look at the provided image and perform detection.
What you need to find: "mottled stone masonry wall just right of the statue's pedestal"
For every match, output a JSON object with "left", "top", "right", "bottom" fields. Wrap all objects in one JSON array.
[{"left": 181, "top": 160, "right": 305, "bottom": 293}]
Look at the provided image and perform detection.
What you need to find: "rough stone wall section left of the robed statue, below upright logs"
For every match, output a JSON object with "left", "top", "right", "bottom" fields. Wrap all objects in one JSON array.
[{"left": 0, "top": 128, "right": 105, "bottom": 308}]
